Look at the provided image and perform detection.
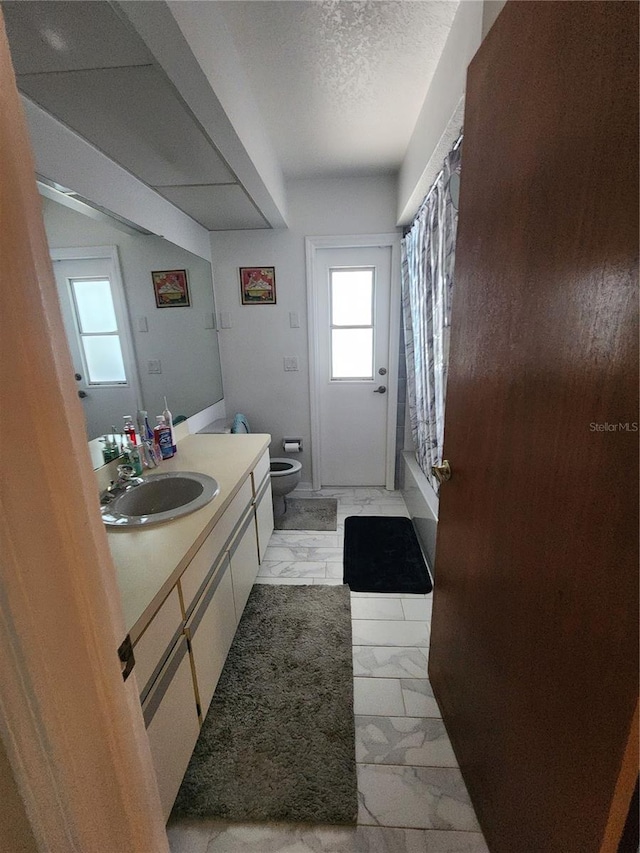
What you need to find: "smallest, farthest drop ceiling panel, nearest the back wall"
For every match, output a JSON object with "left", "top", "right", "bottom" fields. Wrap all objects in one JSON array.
[{"left": 155, "top": 184, "right": 269, "bottom": 231}]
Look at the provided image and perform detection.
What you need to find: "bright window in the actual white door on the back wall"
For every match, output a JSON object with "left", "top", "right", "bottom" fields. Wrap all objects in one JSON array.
[{"left": 329, "top": 267, "right": 375, "bottom": 380}]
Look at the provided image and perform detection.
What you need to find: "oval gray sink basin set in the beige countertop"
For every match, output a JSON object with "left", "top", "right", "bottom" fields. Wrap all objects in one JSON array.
[{"left": 100, "top": 471, "right": 220, "bottom": 527}]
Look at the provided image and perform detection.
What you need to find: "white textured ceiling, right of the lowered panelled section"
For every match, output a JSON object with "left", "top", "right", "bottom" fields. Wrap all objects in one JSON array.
[{"left": 216, "top": 0, "right": 458, "bottom": 176}]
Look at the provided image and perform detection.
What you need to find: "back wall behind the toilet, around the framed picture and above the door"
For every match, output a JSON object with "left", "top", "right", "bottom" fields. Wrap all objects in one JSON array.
[{"left": 211, "top": 176, "right": 396, "bottom": 482}]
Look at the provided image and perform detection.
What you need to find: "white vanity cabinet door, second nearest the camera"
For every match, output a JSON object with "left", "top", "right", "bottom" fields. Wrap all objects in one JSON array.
[{"left": 187, "top": 553, "right": 236, "bottom": 719}]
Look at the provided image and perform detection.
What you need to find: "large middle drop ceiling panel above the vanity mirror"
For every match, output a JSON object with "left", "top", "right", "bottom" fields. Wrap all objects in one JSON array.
[{"left": 18, "top": 65, "right": 236, "bottom": 186}]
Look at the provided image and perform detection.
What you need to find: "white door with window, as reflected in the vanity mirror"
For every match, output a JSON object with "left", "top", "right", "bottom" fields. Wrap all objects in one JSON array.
[{"left": 53, "top": 251, "right": 139, "bottom": 439}]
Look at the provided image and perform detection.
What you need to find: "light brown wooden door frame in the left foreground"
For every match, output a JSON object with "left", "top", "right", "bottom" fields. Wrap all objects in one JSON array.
[{"left": 0, "top": 12, "right": 169, "bottom": 853}]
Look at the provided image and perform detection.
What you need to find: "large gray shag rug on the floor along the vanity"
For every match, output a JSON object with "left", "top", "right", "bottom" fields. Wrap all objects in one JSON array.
[{"left": 173, "top": 584, "right": 358, "bottom": 824}]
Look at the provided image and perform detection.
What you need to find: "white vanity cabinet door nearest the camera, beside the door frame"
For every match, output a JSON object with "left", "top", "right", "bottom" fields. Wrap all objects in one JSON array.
[{"left": 142, "top": 636, "right": 200, "bottom": 820}]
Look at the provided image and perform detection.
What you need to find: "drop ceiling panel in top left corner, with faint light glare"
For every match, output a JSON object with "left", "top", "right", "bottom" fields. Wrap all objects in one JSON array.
[{"left": 2, "top": 0, "right": 152, "bottom": 74}]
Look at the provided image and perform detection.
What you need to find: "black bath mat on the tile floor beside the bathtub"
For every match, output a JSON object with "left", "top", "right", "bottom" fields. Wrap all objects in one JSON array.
[{"left": 344, "top": 515, "right": 433, "bottom": 593}]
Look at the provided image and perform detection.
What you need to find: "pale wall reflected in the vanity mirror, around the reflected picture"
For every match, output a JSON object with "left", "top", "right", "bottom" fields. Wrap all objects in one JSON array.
[{"left": 42, "top": 198, "right": 223, "bottom": 432}]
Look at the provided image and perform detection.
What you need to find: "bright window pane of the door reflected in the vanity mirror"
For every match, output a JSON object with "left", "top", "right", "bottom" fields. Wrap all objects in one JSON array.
[{"left": 68, "top": 278, "right": 127, "bottom": 385}]
